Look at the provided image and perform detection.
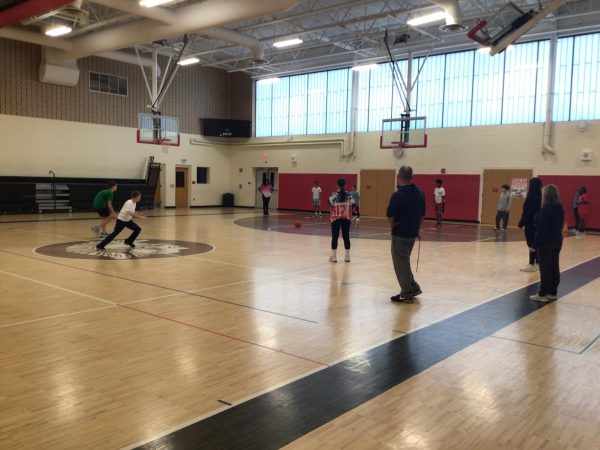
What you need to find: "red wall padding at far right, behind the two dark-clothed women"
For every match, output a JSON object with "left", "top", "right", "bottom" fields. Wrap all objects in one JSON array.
[{"left": 539, "top": 175, "right": 600, "bottom": 228}]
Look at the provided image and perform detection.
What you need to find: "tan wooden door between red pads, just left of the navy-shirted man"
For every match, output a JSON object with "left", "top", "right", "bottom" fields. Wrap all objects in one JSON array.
[{"left": 360, "top": 170, "right": 396, "bottom": 217}]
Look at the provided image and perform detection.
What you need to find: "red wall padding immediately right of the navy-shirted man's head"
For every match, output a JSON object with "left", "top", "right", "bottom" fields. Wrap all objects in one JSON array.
[{"left": 414, "top": 173, "right": 481, "bottom": 221}]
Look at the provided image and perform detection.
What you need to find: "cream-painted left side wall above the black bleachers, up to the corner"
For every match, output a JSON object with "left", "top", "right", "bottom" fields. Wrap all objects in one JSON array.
[{"left": 0, "top": 115, "right": 229, "bottom": 206}]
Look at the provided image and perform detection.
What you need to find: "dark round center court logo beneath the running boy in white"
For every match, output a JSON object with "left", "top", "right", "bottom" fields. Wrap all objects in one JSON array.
[{"left": 35, "top": 239, "right": 213, "bottom": 260}]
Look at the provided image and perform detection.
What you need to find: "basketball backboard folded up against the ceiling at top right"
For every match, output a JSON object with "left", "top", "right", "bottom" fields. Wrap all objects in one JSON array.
[{"left": 467, "top": 0, "right": 568, "bottom": 56}]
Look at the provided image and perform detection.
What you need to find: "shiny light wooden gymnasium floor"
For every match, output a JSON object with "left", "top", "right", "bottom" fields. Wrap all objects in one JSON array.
[{"left": 0, "top": 208, "right": 600, "bottom": 449}]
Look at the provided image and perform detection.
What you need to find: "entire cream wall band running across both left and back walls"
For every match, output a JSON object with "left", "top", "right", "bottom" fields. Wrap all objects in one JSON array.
[{"left": 0, "top": 115, "right": 600, "bottom": 206}]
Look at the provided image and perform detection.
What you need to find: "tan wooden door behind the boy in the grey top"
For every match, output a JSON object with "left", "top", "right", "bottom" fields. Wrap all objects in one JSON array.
[{"left": 481, "top": 169, "right": 533, "bottom": 226}]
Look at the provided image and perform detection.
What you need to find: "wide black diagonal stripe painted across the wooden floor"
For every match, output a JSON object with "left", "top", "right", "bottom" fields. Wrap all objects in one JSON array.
[{"left": 138, "top": 257, "right": 600, "bottom": 450}]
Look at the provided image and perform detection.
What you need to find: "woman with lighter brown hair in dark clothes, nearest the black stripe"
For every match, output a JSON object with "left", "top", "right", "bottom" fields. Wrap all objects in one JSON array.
[{"left": 529, "top": 184, "right": 565, "bottom": 302}]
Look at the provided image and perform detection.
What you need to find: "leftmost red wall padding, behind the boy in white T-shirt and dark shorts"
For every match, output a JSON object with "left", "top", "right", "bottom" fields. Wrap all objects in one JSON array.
[{"left": 278, "top": 173, "right": 357, "bottom": 211}]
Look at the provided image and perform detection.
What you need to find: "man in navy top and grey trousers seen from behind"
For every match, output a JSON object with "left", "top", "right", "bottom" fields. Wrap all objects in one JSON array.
[{"left": 386, "top": 166, "right": 425, "bottom": 303}]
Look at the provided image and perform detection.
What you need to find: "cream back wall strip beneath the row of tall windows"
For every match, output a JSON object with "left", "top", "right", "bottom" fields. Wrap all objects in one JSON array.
[{"left": 229, "top": 121, "right": 600, "bottom": 206}]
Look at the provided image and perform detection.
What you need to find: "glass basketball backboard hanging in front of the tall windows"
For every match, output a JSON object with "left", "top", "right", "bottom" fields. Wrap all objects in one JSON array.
[{"left": 379, "top": 116, "right": 427, "bottom": 149}]
